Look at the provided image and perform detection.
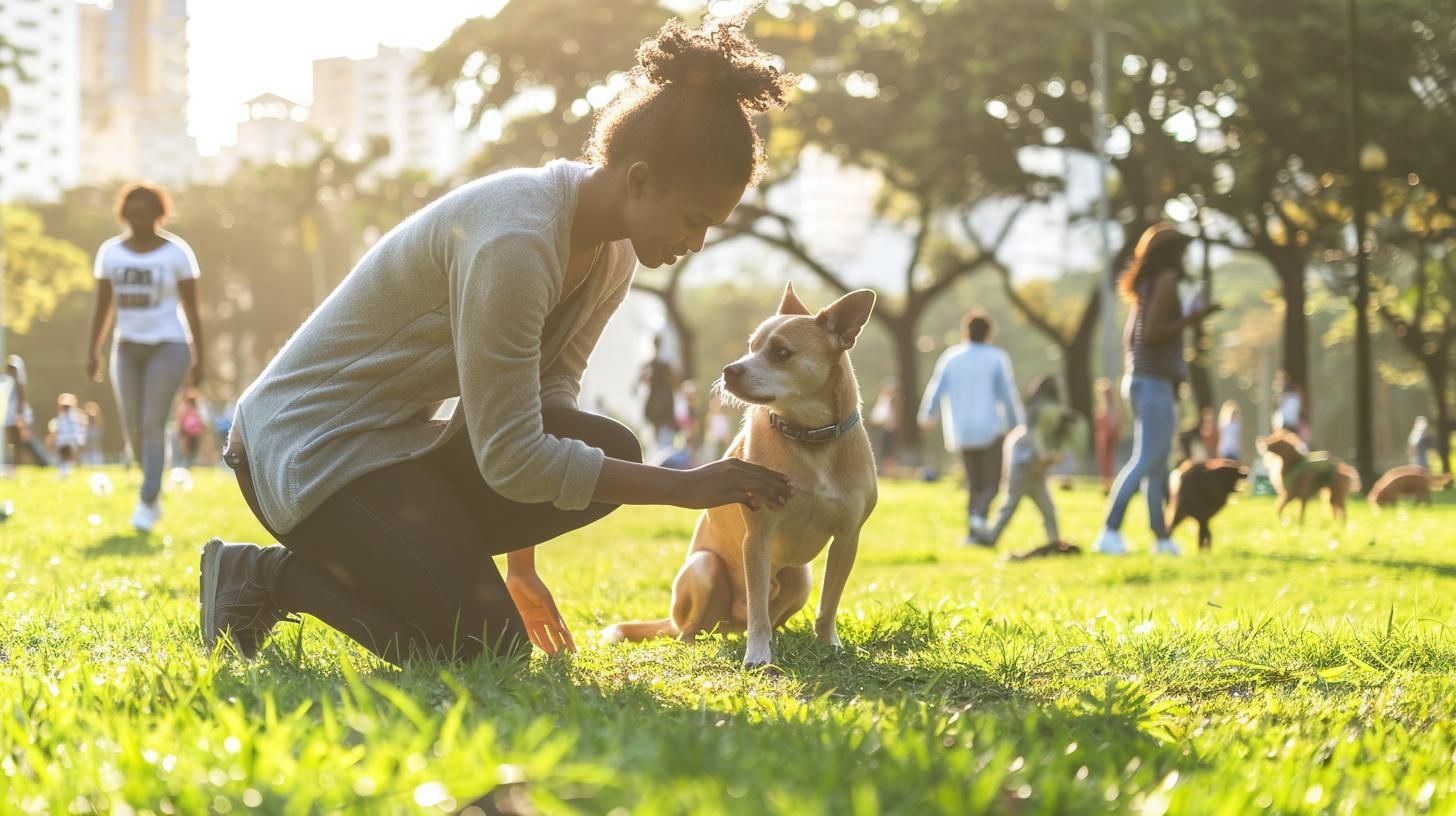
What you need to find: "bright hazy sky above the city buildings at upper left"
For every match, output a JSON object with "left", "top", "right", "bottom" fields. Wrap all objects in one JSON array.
[{"left": 188, "top": 0, "right": 502, "bottom": 154}]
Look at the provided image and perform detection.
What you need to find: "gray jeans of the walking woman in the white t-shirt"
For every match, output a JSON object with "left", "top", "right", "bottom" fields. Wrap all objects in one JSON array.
[{"left": 111, "top": 342, "right": 192, "bottom": 504}]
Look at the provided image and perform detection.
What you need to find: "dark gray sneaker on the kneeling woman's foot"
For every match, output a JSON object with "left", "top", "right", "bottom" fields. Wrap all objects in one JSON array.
[{"left": 198, "top": 538, "right": 297, "bottom": 660}]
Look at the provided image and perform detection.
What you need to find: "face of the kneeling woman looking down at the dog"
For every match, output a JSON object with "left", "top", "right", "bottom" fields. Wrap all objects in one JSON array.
[{"left": 623, "top": 162, "right": 744, "bottom": 268}]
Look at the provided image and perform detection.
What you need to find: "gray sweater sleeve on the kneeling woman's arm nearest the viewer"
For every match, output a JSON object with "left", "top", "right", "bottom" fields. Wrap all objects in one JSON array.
[{"left": 450, "top": 233, "right": 604, "bottom": 510}]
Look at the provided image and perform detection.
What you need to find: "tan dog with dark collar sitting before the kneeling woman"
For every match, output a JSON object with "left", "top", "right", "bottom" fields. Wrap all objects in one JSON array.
[{"left": 603, "top": 284, "right": 878, "bottom": 666}]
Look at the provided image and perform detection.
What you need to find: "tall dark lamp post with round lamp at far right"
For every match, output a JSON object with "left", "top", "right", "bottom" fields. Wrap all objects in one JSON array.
[{"left": 1347, "top": 0, "right": 1386, "bottom": 485}]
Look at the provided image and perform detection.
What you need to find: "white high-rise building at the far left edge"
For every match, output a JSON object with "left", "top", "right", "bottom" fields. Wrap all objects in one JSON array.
[{"left": 0, "top": 0, "right": 80, "bottom": 203}]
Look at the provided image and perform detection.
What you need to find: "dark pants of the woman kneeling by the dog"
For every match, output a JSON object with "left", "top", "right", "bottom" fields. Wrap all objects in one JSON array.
[{"left": 237, "top": 409, "right": 642, "bottom": 664}]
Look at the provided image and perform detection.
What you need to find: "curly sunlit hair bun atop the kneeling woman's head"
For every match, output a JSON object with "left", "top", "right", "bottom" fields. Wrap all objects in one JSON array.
[{"left": 636, "top": 12, "right": 795, "bottom": 112}]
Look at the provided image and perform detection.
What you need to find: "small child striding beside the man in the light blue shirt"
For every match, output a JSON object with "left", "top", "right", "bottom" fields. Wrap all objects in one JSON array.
[{"left": 973, "top": 377, "right": 1086, "bottom": 546}]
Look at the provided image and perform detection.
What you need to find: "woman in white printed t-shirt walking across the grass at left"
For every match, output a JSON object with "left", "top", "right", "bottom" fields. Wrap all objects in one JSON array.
[{"left": 86, "top": 184, "right": 202, "bottom": 532}]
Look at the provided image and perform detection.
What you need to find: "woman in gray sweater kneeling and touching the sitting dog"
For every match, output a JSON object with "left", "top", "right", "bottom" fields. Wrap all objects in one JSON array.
[{"left": 201, "top": 20, "right": 792, "bottom": 663}]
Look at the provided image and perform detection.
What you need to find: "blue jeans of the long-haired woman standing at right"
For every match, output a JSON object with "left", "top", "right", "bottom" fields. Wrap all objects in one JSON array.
[{"left": 1107, "top": 374, "right": 1178, "bottom": 538}]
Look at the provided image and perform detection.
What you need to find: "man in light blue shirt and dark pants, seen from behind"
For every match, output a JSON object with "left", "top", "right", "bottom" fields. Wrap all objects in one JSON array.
[{"left": 920, "top": 309, "right": 1025, "bottom": 544}]
